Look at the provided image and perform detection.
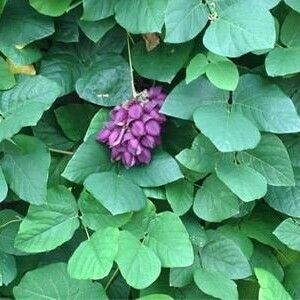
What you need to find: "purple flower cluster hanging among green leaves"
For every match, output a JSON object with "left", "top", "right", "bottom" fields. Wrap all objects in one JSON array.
[{"left": 97, "top": 87, "right": 166, "bottom": 168}]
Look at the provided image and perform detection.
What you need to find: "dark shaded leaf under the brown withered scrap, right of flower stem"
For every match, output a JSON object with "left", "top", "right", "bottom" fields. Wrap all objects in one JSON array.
[{"left": 132, "top": 41, "right": 193, "bottom": 83}]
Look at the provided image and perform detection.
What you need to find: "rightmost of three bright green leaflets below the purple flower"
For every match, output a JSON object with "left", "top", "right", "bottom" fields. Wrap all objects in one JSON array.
[{"left": 145, "top": 212, "right": 194, "bottom": 268}]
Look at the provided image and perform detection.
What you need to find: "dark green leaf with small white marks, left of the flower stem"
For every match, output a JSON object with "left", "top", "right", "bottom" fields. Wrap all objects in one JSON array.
[{"left": 76, "top": 54, "right": 132, "bottom": 106}]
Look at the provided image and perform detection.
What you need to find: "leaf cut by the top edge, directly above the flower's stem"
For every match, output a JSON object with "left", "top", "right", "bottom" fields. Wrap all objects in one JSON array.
[{"left": 115, "top": 0, "right": 168, "bottom": 33}]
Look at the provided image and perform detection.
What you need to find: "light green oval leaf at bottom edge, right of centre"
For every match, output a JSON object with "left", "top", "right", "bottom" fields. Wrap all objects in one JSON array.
[{"left": 194, "top": 268, "right": 238, "bottom": 300}]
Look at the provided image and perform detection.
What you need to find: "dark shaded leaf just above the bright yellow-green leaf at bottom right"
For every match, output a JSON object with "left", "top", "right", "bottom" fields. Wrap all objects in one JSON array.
[{"left": 250, "top": 243, "right": 284, "bottom": 281}]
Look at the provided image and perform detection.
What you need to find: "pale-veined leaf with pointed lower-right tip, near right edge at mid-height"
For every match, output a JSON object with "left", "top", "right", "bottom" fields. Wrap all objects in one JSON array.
[{"left": 238, "top": 134, "right": 295, "bottom": 186}]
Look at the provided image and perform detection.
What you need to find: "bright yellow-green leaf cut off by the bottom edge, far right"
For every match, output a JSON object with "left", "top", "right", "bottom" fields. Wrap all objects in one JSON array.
[{"left": 255, "top": 268, "right": 292, "bottom": 300}]
